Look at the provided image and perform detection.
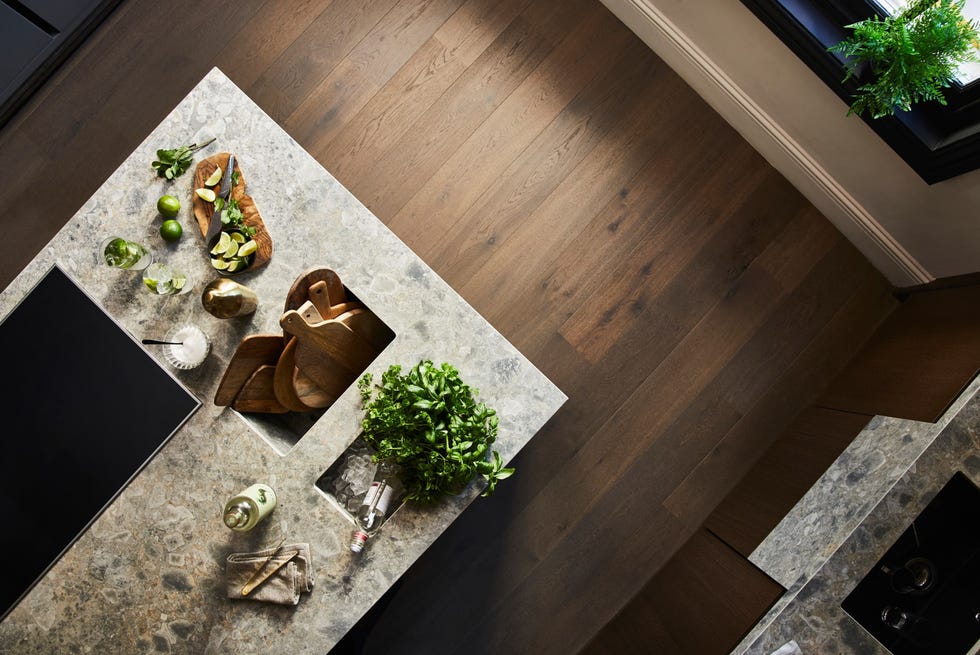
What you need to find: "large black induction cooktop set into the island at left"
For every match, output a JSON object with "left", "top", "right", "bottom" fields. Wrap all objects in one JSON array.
[{"left": 0, "top": 267, "right": 200, "bottom": 619}]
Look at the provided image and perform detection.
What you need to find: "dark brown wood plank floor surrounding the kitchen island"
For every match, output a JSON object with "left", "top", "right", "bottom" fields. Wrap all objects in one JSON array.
[{"left": 0, "top": 0, "right": 893, "bottom": 655}]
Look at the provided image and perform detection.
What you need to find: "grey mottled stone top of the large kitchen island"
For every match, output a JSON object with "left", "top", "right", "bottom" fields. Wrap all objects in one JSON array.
[{"left": 0, "top": 69, "right": 566, "bottom": 655}]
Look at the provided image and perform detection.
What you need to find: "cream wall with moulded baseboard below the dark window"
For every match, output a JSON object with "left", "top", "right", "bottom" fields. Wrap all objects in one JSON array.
[{"left": 602, "top": 0, "right": 980, "bottom": 286}]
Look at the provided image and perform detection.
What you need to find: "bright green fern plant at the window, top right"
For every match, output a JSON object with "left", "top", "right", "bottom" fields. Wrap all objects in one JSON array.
[{"left": 830, "top": 0, "right": 980, "bottom": 118}]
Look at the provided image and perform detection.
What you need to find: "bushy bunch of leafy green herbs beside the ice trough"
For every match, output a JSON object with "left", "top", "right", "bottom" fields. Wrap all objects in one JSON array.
[{"left": 357, "top": 360, "right": 514, "bottom": 503}]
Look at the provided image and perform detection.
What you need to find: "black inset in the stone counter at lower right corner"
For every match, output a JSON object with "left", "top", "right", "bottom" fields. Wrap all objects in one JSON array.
[{"left": 841, "top": 472, "right": 980, "bottom": 655}]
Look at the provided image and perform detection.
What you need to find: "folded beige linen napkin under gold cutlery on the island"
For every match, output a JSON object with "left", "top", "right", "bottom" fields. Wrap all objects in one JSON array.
[{"left": 225, "top": 544, "right": 314, "bottom": 605}]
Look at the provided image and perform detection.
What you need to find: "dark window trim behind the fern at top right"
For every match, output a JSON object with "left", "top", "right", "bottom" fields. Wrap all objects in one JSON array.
[{"left": 741, "top": 0, "right": 980, "bottom": 184}]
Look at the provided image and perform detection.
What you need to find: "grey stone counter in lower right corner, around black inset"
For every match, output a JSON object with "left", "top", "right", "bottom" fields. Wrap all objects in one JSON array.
[{"left": 732, "top": 377, "right": 980, "bottom": 655}]
